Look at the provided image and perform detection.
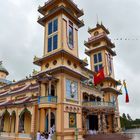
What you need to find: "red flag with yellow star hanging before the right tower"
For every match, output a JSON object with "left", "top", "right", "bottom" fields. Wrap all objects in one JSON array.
[{"left": 94, "top": 68, "right": 105, "bottom": 85}]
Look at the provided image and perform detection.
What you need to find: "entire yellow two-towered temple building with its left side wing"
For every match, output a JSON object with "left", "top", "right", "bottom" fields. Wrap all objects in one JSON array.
[{"left": 0, "top": 0, "right": 121, "bottom": 140}]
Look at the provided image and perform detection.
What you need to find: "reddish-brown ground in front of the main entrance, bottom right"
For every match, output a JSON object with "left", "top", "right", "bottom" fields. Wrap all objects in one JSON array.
[{"left": 85, "top": 134, "right": 131, "bottom": 140}]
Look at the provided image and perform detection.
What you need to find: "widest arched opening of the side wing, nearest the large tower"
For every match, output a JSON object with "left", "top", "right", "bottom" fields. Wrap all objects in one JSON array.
[{"left": 19, "top": 109, "right": 32, "bottom": 134}]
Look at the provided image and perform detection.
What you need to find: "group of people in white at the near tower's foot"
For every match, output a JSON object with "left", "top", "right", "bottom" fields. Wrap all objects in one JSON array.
[{"left": 37, "top": 125, "right": 55, "bottom": 140}]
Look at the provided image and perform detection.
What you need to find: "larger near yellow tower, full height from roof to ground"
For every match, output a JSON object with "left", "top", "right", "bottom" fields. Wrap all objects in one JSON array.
[{"left": 34, "top": 0, "right": 88, "bottom": 140}]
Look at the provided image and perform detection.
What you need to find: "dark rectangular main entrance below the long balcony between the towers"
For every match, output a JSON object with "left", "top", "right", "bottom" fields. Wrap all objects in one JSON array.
[{"left": 87, "top": 115, "right": 98, "bottom": 131}]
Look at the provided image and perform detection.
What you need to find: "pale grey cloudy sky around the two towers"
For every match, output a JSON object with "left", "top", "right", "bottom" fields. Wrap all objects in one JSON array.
[{"left": 0, "top": 0, "right": 140, "bottom": 118}]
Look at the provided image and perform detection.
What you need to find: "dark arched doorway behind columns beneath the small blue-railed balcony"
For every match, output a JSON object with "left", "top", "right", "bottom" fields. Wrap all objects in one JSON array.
[{"left": 46, "top": 112, "right": 55, "bottom": 132}]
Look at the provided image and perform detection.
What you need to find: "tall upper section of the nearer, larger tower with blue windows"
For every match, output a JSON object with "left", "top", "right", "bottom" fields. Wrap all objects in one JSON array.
[{"left": 38, "top": 0, "right": 84, "bottom": 57}]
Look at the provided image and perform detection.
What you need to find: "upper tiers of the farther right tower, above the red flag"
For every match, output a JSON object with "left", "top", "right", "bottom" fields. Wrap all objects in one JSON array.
[{"left": 85, "top": 23, "right": 116, "bottom": 77}]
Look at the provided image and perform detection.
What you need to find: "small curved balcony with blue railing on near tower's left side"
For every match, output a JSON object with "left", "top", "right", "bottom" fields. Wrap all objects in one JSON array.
[{"left": 38, "top": 96, "right": 57, "bottom": 108}]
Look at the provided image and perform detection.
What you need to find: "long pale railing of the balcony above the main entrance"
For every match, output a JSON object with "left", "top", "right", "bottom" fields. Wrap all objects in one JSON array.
[{"left": 83, "top": 101, "right": 115, "bottom": 108}]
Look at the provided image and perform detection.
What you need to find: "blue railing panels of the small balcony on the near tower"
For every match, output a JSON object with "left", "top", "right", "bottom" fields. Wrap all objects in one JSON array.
[{"left": 38, "top": 96, "right": 57, "bottom": 104}]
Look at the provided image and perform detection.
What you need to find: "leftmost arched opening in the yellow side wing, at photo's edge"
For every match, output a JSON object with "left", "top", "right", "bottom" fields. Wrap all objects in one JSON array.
[{"left": 1, "top": 110, "right": 10, "bottom": 133}]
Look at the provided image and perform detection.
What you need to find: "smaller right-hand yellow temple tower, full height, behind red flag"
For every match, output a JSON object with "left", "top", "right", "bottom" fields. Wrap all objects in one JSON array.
[{"left": 85, "top": 23, "right": 121, "bottom": 131}]
